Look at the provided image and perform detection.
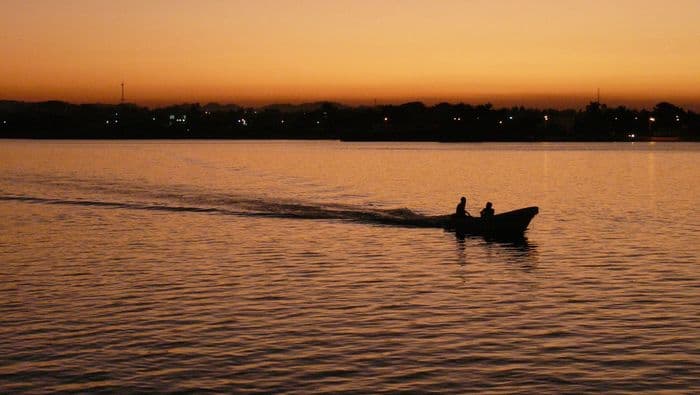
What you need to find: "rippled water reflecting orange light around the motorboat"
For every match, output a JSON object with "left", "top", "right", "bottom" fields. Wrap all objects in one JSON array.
[{"left": 0, "top": 140, "right": 700, "bottom": 394}]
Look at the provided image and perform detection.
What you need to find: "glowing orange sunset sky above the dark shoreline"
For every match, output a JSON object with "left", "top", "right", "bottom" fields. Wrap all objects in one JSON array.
[{"left": 0, "top": 0, "right": 700, "bottom": 109}]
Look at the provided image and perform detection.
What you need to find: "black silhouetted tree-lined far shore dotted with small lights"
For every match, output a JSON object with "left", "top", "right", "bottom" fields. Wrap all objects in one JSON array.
[{"left": 0, "top": 101, "right": 700, "bottom": 141}]
